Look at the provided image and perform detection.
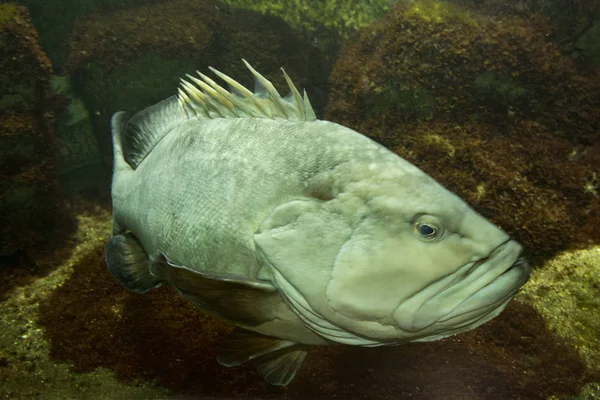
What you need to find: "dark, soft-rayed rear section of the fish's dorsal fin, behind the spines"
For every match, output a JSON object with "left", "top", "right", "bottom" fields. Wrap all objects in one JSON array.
[{"left": 120, "top": 96, "right": 188, "bottom": 169}]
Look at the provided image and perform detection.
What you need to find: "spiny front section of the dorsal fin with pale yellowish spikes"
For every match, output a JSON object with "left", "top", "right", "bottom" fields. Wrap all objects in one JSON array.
[{"left": 179, "top": 60, "right": 317, "bottom": 121}]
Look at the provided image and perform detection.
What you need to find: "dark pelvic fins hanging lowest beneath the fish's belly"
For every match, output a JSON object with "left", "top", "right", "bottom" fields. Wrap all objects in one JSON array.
[{"left": 218, "top": 328, "right": 308, "bottom": 386}]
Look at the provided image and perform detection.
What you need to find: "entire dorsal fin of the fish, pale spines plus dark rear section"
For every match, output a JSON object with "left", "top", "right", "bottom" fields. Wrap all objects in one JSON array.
[{"left": 113, "top": 60, "right": 317, "bottom": 169}]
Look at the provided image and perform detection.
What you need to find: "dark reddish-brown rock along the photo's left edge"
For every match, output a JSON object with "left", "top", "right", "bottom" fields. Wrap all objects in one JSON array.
[{"left": 0, "top": 4, "right": 62, "bottom": 256}]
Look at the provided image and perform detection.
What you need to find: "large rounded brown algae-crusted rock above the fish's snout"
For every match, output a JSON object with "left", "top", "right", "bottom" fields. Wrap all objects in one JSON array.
[{"left": 326, "top": 0, "right": 600, "bottom": 257}]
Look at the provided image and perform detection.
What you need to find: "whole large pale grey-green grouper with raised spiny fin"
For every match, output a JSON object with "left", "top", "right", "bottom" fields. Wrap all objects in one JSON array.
[{"left": 105, "top": 61, "right": 529, "bottom": 385}]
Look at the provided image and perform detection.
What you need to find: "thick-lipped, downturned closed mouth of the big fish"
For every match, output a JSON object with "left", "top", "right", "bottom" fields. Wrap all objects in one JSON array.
[{"left": 394, "top": 240, "right": 530, "bottom": 334}]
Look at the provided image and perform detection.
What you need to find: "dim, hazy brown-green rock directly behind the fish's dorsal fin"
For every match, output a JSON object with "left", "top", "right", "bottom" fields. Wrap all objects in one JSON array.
[{"left": 67, "top": 0, "right": 329, "bottom": 162}]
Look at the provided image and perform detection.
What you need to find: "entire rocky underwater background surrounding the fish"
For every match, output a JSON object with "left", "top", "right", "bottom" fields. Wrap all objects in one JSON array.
[{"left": 0, "top": 0, "right": 600, "bottom": 400}]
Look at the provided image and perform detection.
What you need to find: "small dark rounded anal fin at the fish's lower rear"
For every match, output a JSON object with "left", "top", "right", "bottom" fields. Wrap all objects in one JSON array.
[{"left": 104, "top": 232, "right": 161, "bottom": 293}]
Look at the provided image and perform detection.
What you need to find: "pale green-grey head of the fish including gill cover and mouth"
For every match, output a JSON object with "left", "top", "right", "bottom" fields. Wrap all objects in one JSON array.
[{"left": 255, "top": 155, "right": 529, "bottom": 346}]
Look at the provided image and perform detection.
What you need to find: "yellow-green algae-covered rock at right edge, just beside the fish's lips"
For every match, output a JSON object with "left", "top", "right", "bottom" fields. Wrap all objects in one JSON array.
[{"left": 517, "top": 246, "right": 600, "bottom": 368}]
